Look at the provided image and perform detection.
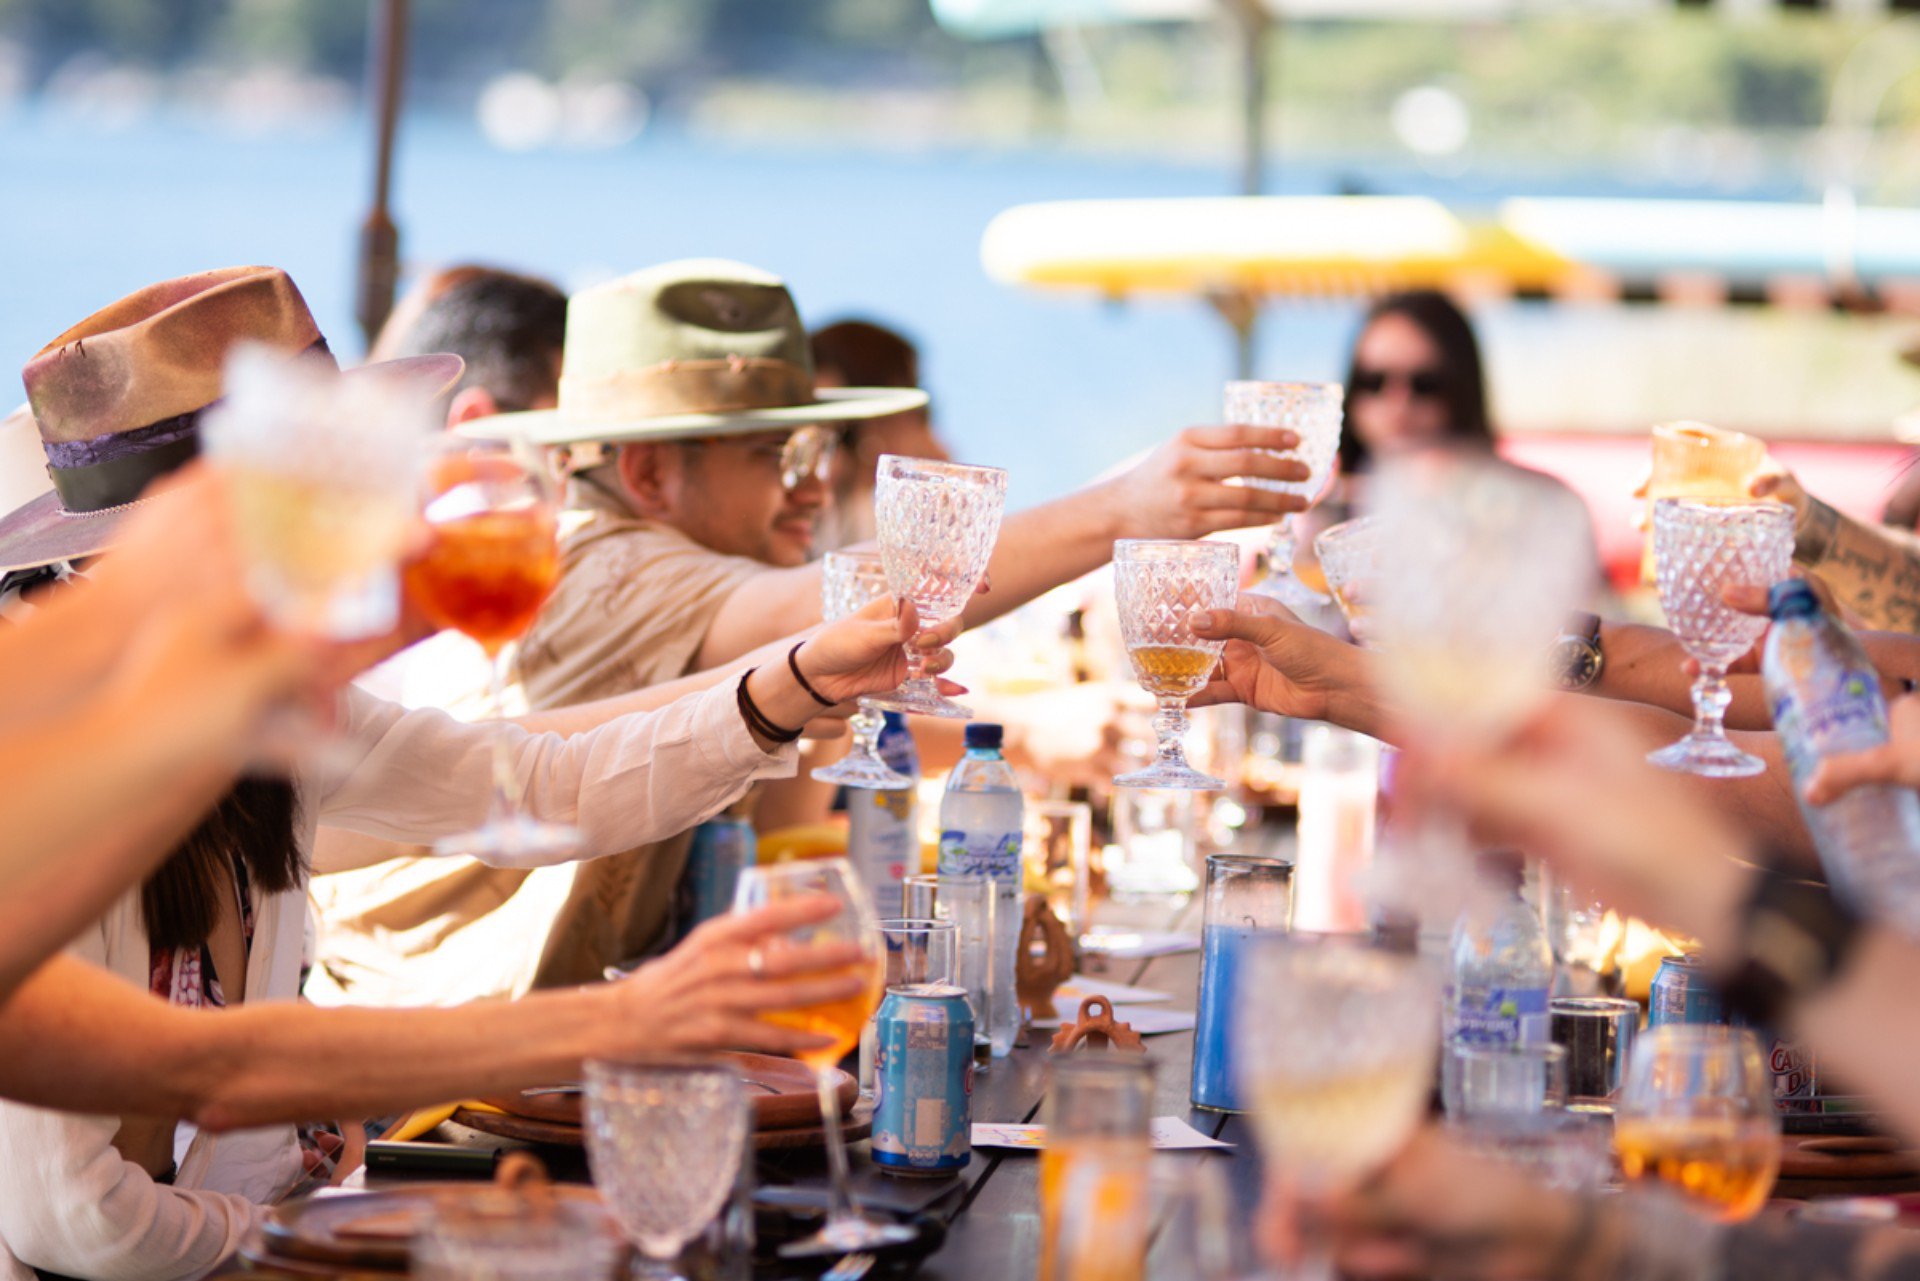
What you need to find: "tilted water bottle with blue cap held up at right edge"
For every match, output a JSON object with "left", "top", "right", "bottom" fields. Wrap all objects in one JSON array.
[{"left": 1764, "top": 578, "right": 1920, "bottom": 930}]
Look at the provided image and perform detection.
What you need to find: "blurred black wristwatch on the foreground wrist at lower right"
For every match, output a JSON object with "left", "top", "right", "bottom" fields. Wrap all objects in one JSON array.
[{"left": 1720, "top": 868, "right": 1860, "bottom": 1027}]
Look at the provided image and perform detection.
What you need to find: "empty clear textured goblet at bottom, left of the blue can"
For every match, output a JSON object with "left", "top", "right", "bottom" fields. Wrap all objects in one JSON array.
[{"left": 579, "top": 1062, "right": 751, "bottom": 1281}]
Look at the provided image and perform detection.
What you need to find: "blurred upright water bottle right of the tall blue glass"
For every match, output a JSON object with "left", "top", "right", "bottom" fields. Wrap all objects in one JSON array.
[{"left": 1448, "top": 857, "right": 1553, "bottom": 1045}]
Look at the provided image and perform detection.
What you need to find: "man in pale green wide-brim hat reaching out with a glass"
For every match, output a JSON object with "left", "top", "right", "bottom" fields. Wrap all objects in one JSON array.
[{"left": 309, "top": 259, "right": 1304, "bottom": 1001}]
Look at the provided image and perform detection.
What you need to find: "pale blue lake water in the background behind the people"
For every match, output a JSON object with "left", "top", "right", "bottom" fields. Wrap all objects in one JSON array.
[{"left": 0, "top": 108, "right": 1382, "bottom": 505}]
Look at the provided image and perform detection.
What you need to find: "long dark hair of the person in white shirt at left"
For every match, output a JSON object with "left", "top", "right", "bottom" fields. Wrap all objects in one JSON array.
[{"left": 140, "top": 778, "right": 303, "bottom": 951}]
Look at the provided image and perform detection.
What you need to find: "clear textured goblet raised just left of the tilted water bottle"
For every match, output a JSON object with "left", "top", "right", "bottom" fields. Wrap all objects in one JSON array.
[{"left": 1647, "top": 497, "right": 1793, "bottom": 778}]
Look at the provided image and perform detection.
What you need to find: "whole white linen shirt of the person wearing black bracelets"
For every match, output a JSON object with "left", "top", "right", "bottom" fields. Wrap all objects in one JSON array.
[{"left": 0, "top": 682, "right": 797, "bottom": 1281}]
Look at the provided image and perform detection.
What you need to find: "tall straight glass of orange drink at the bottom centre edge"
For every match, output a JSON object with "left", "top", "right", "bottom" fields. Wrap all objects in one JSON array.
[{"left": 1041, "top": 1054, "right": 1154, "bottom": 1281}]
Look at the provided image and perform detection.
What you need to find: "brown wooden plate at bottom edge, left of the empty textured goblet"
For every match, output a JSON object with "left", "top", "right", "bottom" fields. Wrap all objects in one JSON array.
[{"left": 261, "top": 1183, "right": 620, "bottom": 1273}]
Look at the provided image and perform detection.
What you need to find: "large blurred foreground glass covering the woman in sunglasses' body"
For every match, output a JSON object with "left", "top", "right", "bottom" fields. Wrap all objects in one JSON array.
[{"left": 1367, "top": 460, "right": 1599, "bottom": 914}]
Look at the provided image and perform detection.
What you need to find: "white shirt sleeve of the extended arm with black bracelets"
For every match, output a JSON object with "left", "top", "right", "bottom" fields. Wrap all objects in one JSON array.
[{"left": 309, "top": 682, "right": 799, "bottom": 872}]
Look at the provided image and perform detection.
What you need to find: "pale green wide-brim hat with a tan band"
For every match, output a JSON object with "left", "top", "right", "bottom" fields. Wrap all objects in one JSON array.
[{"left": 461, "top": 257, "right": 927, "bottom": 446}]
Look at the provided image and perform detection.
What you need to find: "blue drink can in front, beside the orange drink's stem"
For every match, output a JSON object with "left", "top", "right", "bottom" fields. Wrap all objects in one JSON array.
[{"left": 872, "top": 983, "right": 973, "bottom": 1175}]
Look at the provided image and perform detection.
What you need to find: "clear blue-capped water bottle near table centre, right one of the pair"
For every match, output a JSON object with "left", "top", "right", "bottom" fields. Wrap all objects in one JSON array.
[{"left": 941, "top": 722, "right": 1023, "bottom": 1058}]
